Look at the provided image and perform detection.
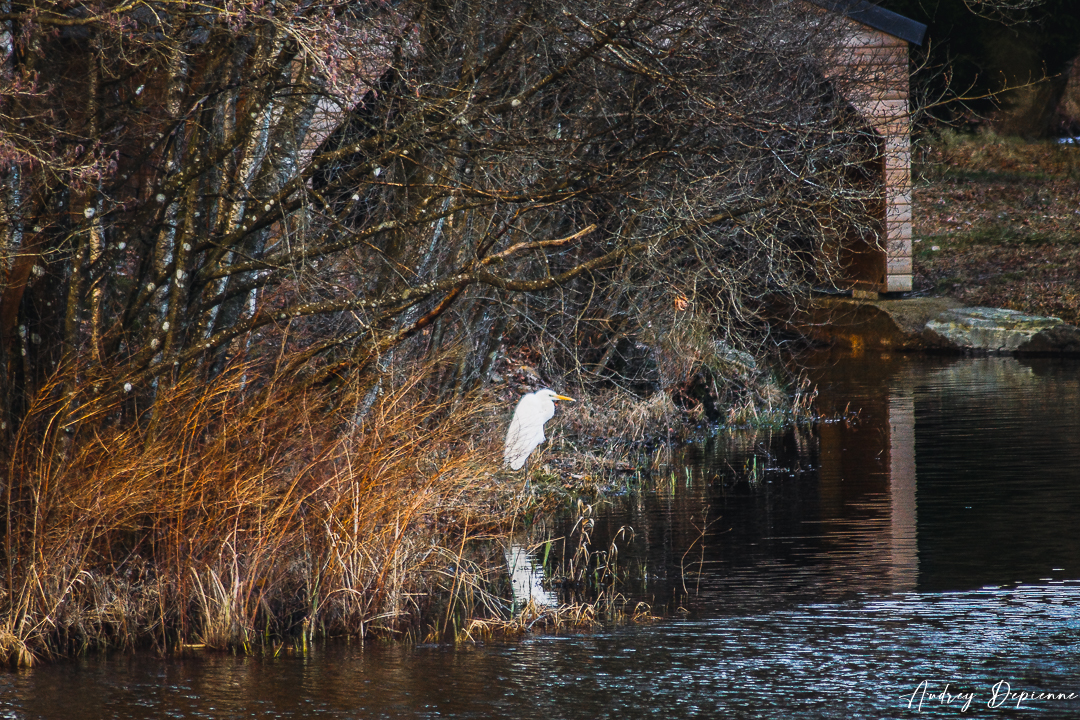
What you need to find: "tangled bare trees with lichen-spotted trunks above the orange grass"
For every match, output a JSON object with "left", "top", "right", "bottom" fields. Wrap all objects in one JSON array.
[{"left": 0, "top": 0, "right": 880, "bottom": 444}]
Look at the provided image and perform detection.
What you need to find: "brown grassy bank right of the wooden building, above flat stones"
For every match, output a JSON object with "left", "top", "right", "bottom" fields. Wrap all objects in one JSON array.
[{"left": 914, "top": 133, "right": 1080, "bottom": 324}]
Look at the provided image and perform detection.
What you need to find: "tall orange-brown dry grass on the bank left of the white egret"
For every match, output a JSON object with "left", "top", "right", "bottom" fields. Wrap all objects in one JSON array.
[{"left": 0, "top": 367, "right": 518, "bottom": 664}]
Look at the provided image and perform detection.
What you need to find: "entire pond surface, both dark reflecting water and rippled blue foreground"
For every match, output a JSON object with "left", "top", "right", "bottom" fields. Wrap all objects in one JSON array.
[{"left": 0, "top": 356, "right": 1080, "bottom": 719}]
